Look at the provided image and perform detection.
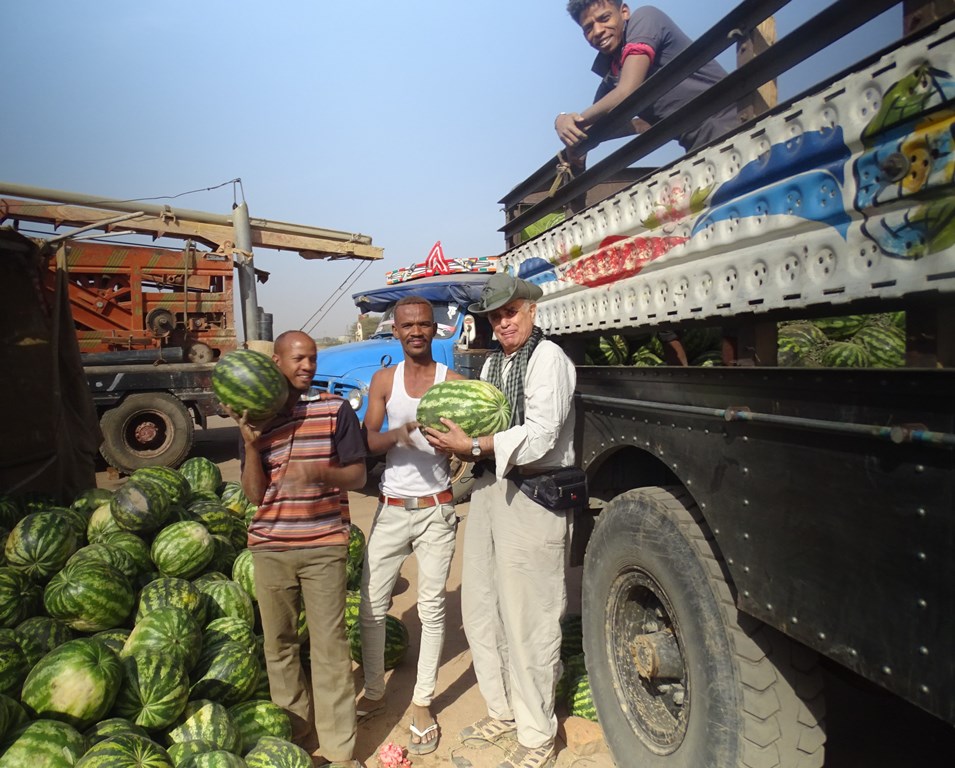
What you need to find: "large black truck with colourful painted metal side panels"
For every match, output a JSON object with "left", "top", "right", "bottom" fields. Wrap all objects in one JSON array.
[{"left": 492, "top": 2, "right": 955, "bottom": 768}]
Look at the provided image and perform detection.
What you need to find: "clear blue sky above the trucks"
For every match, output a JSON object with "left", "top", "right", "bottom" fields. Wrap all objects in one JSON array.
[{"left": 0, "top": 0, "right": 901, "bottom": 336}]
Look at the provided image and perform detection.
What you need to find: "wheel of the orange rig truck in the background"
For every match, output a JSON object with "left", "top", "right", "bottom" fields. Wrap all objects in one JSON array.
[{"left": 100, "top": 392, "right": 194, "bottom": 473}]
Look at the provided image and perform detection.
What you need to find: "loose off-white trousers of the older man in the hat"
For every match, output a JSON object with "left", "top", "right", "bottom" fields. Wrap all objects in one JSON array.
[{"left": 461, "top": 472, "right": 570, "bottom": 749}]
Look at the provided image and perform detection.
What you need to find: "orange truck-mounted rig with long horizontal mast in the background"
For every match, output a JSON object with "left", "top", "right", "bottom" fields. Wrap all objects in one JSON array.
[{"left": 0, "top": 182, "right": 382, "bottom": 473}]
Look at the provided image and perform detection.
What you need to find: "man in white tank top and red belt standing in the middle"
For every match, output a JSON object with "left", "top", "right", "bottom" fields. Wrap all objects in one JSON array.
[{"left": 357, "top": 296, "right": 464, "bottom": 755}]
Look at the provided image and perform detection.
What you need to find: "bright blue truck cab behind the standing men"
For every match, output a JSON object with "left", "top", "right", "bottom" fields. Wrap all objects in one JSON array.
[{"left": 314, "top": 273, "right": 491, "bottom": 420}]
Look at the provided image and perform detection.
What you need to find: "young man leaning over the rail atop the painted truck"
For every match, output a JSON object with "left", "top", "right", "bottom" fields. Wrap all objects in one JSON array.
[{"left": 554, "top": 0, "right": 737, "bottom": 154}]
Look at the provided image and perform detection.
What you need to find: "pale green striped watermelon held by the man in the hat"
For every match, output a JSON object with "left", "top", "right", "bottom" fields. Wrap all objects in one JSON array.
[{"left": 417, "top": 379, "right": 511, "bottom": 437}]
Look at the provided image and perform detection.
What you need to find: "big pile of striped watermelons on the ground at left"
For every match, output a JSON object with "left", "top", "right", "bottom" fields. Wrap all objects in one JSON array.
[{"left": 0, "top": 458, "right": 404, "bottom": 768}]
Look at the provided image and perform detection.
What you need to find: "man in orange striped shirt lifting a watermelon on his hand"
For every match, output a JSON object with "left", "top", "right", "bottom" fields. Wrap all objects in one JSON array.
[{"left": 237, "top": 331, "right": 366, "bottom": 766}]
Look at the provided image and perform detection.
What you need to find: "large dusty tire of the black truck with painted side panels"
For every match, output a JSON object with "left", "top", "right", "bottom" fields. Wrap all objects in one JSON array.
[{"left": 582, "top": 488, "right": 825, "bottom": 768}]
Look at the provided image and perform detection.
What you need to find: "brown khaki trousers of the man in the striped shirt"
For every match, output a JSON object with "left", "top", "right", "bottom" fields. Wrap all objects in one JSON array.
[{"left": 252, "top": 546, "right": 357, "bottom": 761}]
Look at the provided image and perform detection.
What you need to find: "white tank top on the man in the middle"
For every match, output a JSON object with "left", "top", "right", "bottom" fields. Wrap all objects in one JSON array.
[{"left": 381, "top": 361, "right": 451, "bottom": 498}]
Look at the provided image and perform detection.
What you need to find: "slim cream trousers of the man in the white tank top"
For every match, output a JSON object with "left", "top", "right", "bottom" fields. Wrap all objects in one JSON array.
[{"left": 359, "top": 503, "right": 457, "bottom": 707}]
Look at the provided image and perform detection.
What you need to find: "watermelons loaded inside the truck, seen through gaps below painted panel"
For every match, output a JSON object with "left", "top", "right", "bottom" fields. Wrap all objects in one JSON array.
[{"left": 584, "top": 312, "right": 905, "bottom": 368}]
